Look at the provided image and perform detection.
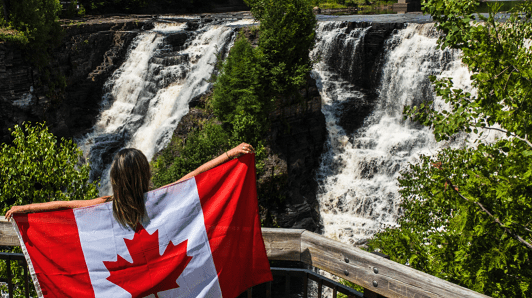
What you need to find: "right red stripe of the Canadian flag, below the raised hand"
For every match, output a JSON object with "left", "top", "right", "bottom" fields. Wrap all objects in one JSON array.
[{"left": 195, "top": 154, "right": 272, "bottom": 298}]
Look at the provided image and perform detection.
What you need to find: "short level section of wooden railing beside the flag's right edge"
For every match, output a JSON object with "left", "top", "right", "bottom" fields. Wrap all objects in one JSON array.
[{"left": 262, "top": 228, "right": 305, "bottom": 261}]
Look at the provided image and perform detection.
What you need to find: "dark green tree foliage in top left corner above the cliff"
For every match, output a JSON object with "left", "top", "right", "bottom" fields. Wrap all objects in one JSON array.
[{"left": 0, "top": 0, "right": 62, "bottom": 67}]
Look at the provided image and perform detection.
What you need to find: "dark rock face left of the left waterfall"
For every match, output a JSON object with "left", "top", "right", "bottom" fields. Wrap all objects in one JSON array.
[{"left": 0, "top": 19, "right": 153, "bottom": 142}]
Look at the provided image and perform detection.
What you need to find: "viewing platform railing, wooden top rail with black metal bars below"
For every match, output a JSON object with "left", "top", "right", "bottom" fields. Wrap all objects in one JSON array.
[{"left": 0, "top": 216, "right": 488, "bottom": 298}]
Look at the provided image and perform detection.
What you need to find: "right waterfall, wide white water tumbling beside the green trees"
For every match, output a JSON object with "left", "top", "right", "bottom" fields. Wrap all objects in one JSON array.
[{"left": 312, "top": 22, "right": 470, "bottom": 245}]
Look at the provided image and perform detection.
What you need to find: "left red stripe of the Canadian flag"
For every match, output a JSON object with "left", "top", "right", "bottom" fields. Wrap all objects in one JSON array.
[{"left": 14, "top": 209, "right": 94, "bottom": 298}]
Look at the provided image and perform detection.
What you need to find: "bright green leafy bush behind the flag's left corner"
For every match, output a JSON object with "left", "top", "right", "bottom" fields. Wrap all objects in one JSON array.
[{"left": 0, "top": 123, "right": 98, "bottom": 297}]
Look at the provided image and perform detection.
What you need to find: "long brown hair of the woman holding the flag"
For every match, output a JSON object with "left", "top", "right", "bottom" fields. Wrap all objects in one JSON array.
[{"left": 111, "top": 148, "right": 151, "bottom": 230}]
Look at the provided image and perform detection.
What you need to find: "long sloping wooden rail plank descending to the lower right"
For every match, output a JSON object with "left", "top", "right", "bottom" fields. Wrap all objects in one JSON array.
[{"left": 301, "top": 231, "right": 488, "bottom": 298}]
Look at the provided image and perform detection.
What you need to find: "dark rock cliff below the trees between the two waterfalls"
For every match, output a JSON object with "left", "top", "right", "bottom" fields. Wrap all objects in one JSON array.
[{"left": 258, "top": 77, "right": 327, "bottom": 231}]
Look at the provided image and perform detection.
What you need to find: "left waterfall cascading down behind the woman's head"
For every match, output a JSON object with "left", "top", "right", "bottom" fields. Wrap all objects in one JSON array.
[{"left": 78, "top": 21, "right": 250, "bottom": 195}]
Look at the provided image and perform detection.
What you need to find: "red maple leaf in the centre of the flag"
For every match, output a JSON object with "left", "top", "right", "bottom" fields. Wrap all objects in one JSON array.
[{"left": 103, "top": 224, "right": 192, "bottom": 298}]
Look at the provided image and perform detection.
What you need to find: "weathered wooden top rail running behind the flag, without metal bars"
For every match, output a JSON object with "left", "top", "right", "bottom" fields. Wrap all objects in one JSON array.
[{"left": 0, "top": 216, "right": 488, "bottom": 298}]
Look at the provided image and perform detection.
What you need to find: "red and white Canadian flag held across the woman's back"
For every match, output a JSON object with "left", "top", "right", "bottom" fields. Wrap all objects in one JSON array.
[{"left": 14, "top": 154, "right": 272, "bottom": 298}]
